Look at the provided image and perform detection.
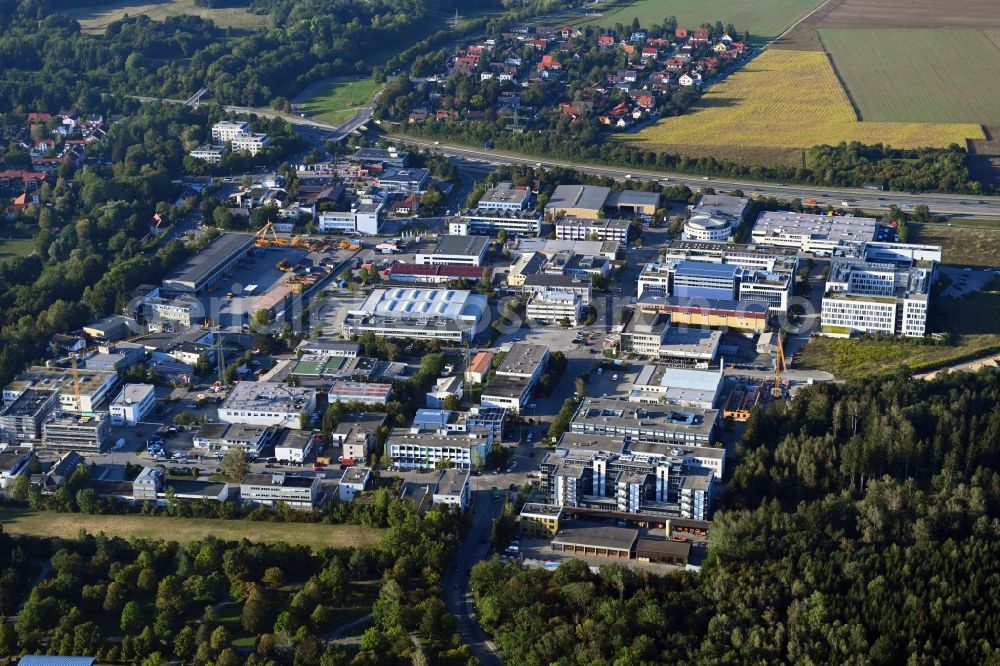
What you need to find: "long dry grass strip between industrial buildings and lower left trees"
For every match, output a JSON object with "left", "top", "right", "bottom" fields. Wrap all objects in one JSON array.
[{"left": 0, "top": 507, "right": 385, "bottom": 549}]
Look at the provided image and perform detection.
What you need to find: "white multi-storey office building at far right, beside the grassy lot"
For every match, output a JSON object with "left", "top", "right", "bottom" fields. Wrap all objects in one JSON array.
[{"left": 821, "top": 261, "right": 933, "bottom": 337}]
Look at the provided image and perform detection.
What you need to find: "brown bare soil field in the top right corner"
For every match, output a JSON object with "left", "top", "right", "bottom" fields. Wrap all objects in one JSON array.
[{"left": 804, "top": 0, "right": 1000, "bottom": 28}]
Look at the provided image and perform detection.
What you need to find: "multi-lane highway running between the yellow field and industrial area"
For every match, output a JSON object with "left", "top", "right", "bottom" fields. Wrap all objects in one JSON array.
[{"left": 389, "top": 134, "right": 1000, "bottom": 218}]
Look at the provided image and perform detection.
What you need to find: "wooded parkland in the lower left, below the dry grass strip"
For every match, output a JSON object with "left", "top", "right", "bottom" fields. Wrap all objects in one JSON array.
[{"left": 0, "top": 497, "right": 470, "bottom": 666}]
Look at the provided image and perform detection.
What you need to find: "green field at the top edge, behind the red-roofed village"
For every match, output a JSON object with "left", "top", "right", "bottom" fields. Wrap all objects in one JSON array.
[{"left": 586, "top": 0, "right": 823, "bottom": 39}]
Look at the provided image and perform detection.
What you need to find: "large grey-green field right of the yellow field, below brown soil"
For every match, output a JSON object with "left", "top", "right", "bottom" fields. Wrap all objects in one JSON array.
[{"left": 819, "top": 28, "right": 1000, "bottom": 125}]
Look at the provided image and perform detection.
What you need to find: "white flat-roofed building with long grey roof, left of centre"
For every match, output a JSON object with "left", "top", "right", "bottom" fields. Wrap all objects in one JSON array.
[{"left": 219, "top": 382, "right": 316, "bottom": 429}]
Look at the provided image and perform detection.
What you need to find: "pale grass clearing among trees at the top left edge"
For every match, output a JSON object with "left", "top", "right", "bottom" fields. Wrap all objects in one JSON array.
[{"left": 62, "top": 0, "right": 268, "bottom": 32}]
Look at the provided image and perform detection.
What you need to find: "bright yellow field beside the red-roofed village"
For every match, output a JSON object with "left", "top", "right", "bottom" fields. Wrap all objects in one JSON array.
[{"left": 621, "top": 49, "right": 984, "bottom": 149}]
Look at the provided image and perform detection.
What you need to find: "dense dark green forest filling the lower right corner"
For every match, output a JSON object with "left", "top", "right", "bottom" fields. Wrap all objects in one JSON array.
[{"left": 473, "top": 370, "right": 1000, "bottom": 666}]
